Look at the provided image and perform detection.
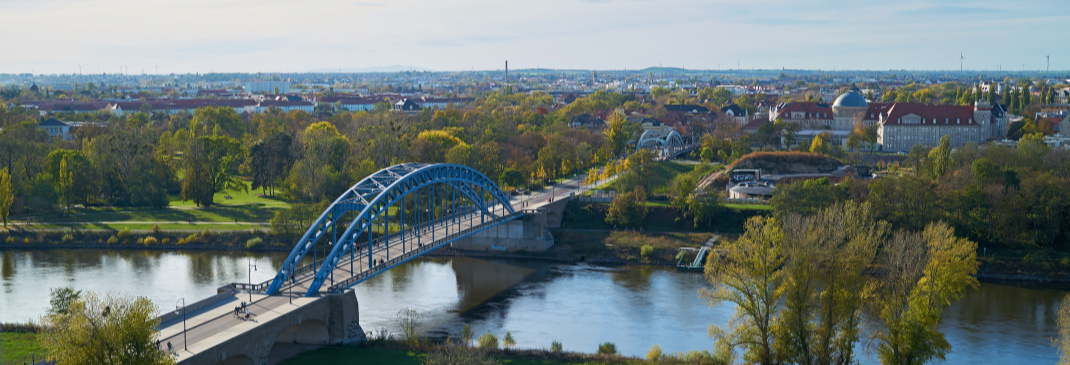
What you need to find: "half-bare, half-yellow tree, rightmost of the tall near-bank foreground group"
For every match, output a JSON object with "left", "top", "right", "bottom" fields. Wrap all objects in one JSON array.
[{"left": 870, "top": 223, "right": 977, "bottom": 364}]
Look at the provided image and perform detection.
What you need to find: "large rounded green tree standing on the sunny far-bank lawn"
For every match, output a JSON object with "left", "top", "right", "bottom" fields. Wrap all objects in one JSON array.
[{"left": 182, "top": 136, "right": 248, "bottom": 207}]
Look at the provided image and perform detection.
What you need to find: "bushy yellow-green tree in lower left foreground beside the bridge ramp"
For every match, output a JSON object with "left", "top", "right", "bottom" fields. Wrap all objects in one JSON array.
[{"left": 43, "top": 292, "right": 174, "bottom": 365}]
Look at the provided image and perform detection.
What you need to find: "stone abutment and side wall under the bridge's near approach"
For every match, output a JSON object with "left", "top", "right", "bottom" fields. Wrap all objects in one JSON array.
[{"left": 178, "top": 291, "right": 367, "bottom": 365}]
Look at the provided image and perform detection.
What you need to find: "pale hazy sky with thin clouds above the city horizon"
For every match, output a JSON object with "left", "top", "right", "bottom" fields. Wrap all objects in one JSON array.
[{"left": 0, "top": 0, "right": 1070, "bottom": 74}]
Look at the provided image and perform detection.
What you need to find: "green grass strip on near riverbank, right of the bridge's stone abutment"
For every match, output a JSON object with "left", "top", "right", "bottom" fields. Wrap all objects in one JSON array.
[{"left": 279, "top": 346, "right": 624, "bottom": 365}]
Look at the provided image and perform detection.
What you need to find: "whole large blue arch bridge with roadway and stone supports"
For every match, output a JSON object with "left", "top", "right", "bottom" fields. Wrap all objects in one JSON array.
[{"left": 158, "top": 164, "right": 585, "bottom": 364}]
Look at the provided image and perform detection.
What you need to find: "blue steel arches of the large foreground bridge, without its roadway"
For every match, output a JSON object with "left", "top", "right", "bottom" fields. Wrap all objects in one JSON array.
[{"left": 268, "top": 164, "right": 515, "bottom": 295}]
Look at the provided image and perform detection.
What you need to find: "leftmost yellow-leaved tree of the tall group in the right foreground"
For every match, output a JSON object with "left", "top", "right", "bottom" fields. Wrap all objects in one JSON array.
[{"left": 700, "top": 216, "right": 784, "bottom": 364}]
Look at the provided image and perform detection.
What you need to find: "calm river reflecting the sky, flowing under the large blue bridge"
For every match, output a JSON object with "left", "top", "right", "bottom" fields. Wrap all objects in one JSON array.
[{"left": 0, "top": 249, "right": 1067, "bottom": 364}]
